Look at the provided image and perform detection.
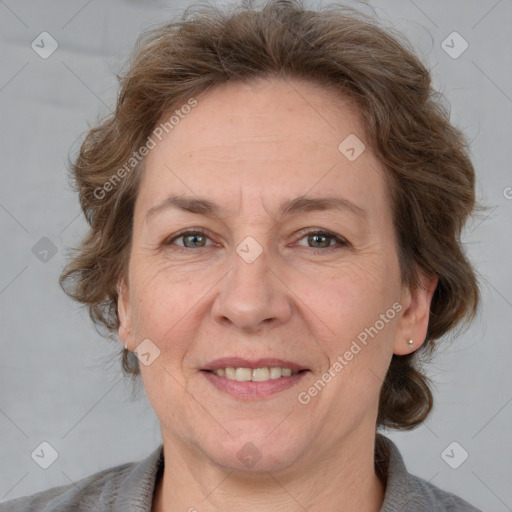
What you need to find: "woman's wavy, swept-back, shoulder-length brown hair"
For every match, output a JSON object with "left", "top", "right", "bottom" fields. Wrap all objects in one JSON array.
[{"left": 60, "top": 0, "right": 479, "bottom": 429}]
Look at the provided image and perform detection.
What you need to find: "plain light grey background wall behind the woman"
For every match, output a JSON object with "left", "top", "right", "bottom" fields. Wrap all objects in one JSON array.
[{"left": 0, "top": 0, "right": 512, "bottom": 512}]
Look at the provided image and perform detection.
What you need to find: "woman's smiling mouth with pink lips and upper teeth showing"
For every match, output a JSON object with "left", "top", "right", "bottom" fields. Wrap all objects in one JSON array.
[{"left": 201, "top": 358, "right": 310, "bottom": 399}]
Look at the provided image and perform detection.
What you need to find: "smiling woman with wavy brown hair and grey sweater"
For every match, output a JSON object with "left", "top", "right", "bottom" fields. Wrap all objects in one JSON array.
[{"left": 0, "top": 0, "right": 479, "bottom": 512}]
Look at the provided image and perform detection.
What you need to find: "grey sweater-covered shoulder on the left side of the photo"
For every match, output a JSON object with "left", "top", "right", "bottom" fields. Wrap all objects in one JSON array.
[{"left": 0, "top": 446, "right": 163, "bottom": 512}]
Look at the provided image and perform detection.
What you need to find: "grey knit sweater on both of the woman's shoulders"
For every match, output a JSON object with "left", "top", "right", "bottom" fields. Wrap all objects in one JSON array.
[{"left": 0, "top": 434, "right": 481, "bottom": 512}]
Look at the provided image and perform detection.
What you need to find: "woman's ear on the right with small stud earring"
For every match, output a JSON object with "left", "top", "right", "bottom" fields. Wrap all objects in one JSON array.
[{"left": 393, "top": 274, "right": 438, "bottom": 356}]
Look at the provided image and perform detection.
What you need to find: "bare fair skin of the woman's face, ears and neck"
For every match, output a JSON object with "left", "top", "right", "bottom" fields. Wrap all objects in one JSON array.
[{"left": 118, "top": 79, "right": 436, "bottom": 512}]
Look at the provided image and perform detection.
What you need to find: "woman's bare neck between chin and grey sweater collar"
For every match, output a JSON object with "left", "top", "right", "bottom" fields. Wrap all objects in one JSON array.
[{"left": 152, "top": 434, "right": 385, "bottom": 512}]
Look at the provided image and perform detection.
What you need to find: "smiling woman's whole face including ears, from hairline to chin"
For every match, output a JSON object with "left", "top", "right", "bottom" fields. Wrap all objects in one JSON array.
[{"left": 119, "top": 81, "right": 433, "bottom": 471}]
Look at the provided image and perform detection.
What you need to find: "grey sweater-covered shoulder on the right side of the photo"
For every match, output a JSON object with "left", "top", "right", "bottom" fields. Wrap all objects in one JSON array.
[{"left": 377, "top": 434, "right": 482, "bottom": 512}]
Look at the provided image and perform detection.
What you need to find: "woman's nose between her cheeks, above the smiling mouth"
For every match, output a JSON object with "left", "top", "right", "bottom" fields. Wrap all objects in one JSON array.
[{"left": 212, "top": 247, "right": 293, "bottom": 333}]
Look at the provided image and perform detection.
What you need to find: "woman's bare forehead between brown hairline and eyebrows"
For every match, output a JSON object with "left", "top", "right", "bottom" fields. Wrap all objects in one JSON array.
[{"left": 138, "top": 80, "right": 386, "bottom": 222}]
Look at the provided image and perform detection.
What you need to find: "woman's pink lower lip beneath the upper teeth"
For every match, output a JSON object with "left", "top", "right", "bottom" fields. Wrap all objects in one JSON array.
[{"left": 201, "top": 370, "right": 309, "bottom": 400}]
